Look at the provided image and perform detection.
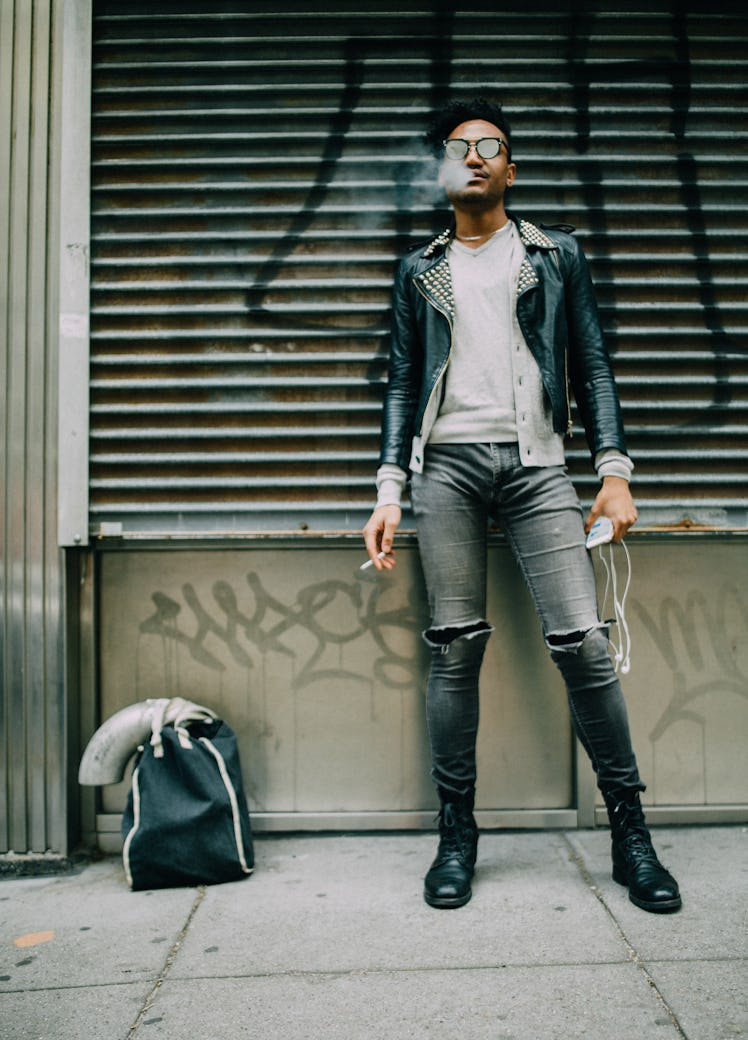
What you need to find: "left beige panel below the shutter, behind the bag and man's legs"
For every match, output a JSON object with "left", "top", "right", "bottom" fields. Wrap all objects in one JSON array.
[{"left": 92, "top": 539, "right": 575, "bottom": 829}]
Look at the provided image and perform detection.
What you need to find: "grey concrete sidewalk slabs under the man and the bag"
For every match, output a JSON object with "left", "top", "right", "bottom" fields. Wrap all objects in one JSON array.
[{"left": 0, "top": 827, "right": 748, "bottom": 1040}]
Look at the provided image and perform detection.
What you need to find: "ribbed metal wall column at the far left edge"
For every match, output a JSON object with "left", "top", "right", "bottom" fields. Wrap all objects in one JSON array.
[{"left": 0, "top": 0, "right": 68, "bottom": 853}]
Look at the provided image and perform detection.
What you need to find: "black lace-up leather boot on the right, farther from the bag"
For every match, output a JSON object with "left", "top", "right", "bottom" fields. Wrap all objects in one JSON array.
[{"left": 604, "top": 789, "right": 681, "bottom": 913}]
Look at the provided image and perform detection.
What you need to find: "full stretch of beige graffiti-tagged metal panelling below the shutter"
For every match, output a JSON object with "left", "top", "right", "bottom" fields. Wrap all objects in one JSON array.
[{"left": 98, "top": 534, "right": 748, "bottom": 849}]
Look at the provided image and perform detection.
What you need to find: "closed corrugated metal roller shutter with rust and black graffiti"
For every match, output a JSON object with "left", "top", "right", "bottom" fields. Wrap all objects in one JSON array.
[{"left": 91, "top": 0, "right": 748, "bottom": 536}]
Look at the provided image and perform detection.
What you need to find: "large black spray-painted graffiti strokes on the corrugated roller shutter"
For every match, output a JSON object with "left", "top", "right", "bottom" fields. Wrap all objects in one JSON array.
[{"left": 247, "top": 8, "right": 745, "bottom": 401}]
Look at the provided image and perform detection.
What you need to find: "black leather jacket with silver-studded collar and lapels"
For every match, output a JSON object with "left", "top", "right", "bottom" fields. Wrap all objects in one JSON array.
[{"left": 380, "top": 214, "right": 626, "bottom": 471}]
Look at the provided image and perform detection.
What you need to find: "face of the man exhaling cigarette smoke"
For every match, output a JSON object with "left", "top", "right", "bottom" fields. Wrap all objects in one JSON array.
[{"left": 439, "top": 120, "right": 517, "bottom": 209}]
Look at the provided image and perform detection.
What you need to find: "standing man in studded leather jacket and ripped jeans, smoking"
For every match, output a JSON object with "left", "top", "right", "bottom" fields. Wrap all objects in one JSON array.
[{"left": 363, "top": 98, "right": 680, "bottom": 912}]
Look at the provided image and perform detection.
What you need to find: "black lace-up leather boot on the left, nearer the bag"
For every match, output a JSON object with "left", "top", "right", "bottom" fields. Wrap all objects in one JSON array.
[{"left": 423, "top": 799, "right": 478, "bottom": 909}]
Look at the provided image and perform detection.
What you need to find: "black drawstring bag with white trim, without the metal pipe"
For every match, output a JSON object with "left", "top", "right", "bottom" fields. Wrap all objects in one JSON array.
[{"left": 122, "top": 698, "right": 254, "bottom": 890}]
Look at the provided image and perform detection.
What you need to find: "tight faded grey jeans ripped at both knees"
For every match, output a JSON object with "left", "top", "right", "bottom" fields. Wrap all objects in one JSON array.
[{"left": 411, "top": 444, "right": 644, "bottom": 796}]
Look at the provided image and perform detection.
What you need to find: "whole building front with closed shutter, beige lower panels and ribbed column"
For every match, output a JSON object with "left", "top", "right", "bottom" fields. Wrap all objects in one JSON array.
[{"left": 0, "top": 0, "right": 748, "bottom": 855}]
